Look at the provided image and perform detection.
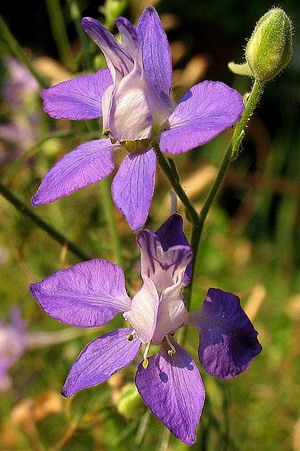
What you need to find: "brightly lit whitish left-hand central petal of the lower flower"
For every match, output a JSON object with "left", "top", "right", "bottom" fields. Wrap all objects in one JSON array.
[{"left": 123, "top": 276, "right": 159, "bottom": 343}]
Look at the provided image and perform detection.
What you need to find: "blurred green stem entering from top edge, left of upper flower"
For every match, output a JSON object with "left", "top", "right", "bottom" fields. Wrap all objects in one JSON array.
[{"left": 46, "top": 0, "right": 76, "bottom": 72}]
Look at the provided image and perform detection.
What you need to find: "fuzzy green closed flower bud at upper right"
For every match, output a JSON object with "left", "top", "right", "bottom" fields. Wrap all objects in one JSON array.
[{"left": 245, "top": 8, "right": 293, "bottom": 81}]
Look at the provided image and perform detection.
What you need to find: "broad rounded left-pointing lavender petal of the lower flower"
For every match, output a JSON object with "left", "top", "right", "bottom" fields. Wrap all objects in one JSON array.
[{"left": 30, "top": 259, "right": 131, "bottom": 327}]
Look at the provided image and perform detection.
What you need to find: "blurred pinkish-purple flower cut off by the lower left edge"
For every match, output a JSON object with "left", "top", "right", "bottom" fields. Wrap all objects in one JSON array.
[{"left": 0, "top": 309, "right": 27, "bottom": 391}]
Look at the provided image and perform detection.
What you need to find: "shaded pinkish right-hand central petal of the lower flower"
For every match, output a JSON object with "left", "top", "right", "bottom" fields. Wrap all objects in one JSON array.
[{"left": 152, "top": 285, "right": 188, "bottom": 344}]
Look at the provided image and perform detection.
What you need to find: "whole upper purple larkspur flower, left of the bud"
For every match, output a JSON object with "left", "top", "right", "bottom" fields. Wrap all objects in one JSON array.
[{"left": 32, "top": 6, "right": 244, "bottom": 230}]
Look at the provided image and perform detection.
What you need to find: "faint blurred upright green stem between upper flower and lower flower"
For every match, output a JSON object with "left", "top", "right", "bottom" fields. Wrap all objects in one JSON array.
[{"left": 100, "top": 178, "right": 123, "bottom": 266}]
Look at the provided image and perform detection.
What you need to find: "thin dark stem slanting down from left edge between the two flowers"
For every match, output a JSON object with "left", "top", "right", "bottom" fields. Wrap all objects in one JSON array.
[{"left": 0, "top": 182, "right": 91, "bottom": 260}]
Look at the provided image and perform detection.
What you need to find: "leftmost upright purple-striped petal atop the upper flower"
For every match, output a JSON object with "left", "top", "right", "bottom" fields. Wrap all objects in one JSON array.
[{"left": 81, "top": 17, "right": 134, "bottom": 82}]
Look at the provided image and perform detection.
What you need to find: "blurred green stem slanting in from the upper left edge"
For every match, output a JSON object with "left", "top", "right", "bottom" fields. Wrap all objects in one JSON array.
[{"left": 0, "top": 15, "right": 50, "bottom": 88}]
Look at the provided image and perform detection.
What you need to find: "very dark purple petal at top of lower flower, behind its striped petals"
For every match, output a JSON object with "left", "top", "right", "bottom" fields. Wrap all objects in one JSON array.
[{"left": 155, "top": 213, "right": 192, "bottom": 285}]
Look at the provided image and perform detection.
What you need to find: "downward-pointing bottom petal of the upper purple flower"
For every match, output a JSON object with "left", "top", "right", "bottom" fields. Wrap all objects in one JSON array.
[{"left": 112, "top": 149, "right": 156, "bottom": 230}]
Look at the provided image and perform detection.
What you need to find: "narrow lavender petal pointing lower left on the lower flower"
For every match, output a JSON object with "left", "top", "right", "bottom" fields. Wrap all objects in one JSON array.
[{"left": 62, "top": 329, "right": 141, "bottom": 397}]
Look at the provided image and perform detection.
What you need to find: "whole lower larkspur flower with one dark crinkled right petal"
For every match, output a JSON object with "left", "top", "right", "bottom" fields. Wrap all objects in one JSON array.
[{"left": 30, "top": 214, "right": 261, "bottom": 445}]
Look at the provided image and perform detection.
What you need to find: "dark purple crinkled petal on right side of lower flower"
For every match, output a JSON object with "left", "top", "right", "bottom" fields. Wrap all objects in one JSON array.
[{"left": 190, "top": 288, "right": 262, "bottom": 379}]
